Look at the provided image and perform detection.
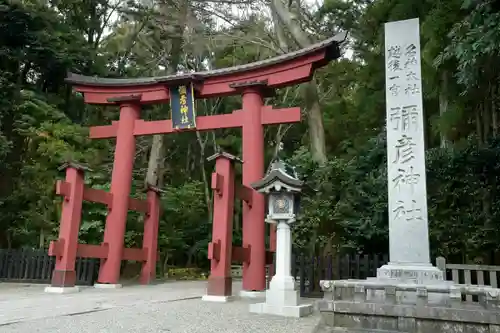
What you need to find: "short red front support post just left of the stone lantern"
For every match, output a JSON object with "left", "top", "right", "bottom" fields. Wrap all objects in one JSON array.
[{"left": 207, "top": 155, "right": 234, "bottom": 296}]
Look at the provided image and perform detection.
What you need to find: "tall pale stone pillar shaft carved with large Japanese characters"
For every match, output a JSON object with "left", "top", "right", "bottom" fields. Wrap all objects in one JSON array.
[{"left": 385, "top": 19, "right": 428, "bottom": 262}]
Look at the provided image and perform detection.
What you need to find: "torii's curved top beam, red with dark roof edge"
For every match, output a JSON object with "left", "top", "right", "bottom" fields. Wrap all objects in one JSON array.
[{"left": 66, "top": 33, "right": 347, "bottom": 104}]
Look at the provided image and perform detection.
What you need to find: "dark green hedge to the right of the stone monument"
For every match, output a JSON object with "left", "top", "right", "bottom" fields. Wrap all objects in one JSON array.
[{"left": 427, "top": 140, "right": 500, "bottom": 262}]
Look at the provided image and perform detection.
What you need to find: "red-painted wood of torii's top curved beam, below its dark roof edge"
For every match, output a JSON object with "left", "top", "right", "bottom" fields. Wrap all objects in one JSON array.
[{"left": 74, "top": 49, "right": 326, "bottom": 104}]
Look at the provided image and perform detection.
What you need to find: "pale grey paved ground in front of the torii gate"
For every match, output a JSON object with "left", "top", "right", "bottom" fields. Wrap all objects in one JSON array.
[{"left": 0, "top": 281, "right": 319, "bottom": 333}]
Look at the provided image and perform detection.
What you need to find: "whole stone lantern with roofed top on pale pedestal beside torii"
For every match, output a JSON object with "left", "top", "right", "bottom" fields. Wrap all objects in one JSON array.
[{"left": 250, "top": 158, "right": 312, "bottom": 317}]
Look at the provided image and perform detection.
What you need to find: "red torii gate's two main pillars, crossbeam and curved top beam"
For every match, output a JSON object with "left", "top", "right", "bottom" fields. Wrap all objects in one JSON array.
[{"left": 54, "top": 33, "right": 346, "bottom": 291}]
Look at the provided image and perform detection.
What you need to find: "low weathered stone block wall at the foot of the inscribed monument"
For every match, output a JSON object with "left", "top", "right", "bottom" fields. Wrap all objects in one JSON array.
[{"left": 315, "top": 280, "right": 500, "bottom": 333}]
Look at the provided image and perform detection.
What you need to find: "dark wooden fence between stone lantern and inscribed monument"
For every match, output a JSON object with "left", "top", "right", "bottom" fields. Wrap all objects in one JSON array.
[{"left": 292, "top": 254, "right": 389, "bottom": 298}]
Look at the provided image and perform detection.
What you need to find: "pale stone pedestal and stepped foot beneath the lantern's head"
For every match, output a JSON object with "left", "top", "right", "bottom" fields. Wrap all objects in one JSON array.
[{"left": 250, "top": 221, "right": 313, "bottom": 317}]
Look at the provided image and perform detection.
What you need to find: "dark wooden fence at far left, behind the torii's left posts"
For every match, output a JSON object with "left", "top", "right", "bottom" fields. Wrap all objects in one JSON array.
[{"left": 0, "top": 249, "right": 99, "bottom": 286}]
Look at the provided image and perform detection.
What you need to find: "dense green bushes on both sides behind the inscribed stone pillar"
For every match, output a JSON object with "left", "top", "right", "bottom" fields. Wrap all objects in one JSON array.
[{"left": 294, "top": 135, "right": 500, "bottom": 262}]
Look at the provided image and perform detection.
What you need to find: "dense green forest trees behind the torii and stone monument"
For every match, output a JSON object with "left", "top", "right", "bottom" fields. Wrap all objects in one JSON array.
[{"left": 0, "top": 0, "right": 500, "bottom": 274}]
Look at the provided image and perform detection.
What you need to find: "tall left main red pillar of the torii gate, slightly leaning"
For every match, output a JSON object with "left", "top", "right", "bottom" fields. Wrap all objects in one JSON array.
[{"left": 98, "top": 103, "right": 140, "bottom": 284}]
